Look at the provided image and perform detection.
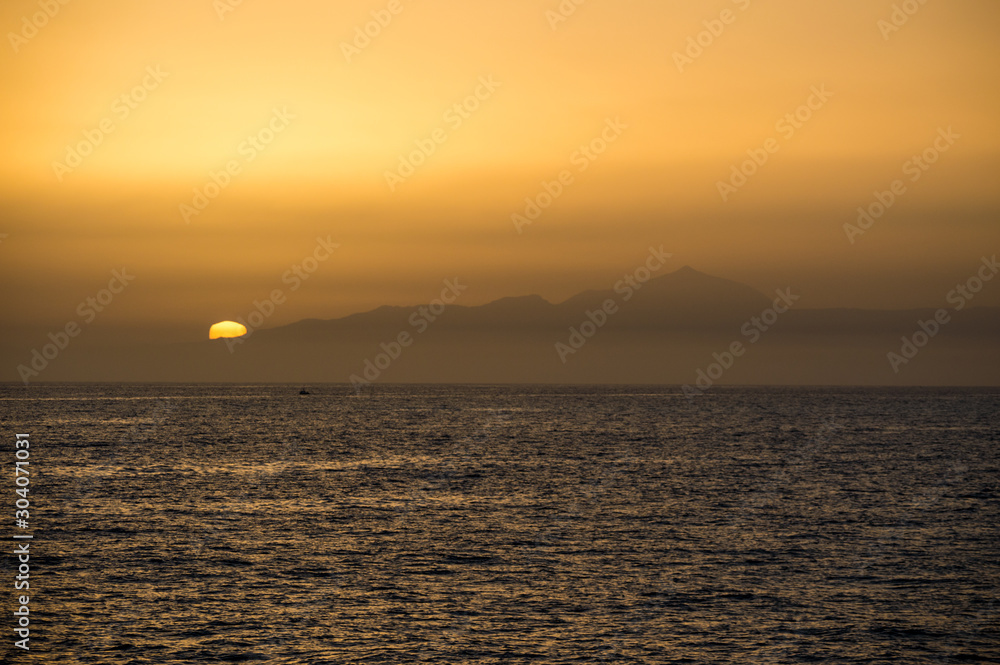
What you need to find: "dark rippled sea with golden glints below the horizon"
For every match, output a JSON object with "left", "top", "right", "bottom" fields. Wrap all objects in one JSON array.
[{"left": 0, "top": 385, "right": 1000, "bottom": 665}]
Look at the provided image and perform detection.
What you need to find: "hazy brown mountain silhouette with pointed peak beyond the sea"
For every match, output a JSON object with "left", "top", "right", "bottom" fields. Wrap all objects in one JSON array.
[{"left": 7, "top": 266, "right": 1000, "bottom": 387}]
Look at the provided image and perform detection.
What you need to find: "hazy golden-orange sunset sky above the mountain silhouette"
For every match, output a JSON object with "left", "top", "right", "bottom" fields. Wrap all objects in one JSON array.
[{"left": 0, "top": 0, "right": 1000, "bottom": 336}]
